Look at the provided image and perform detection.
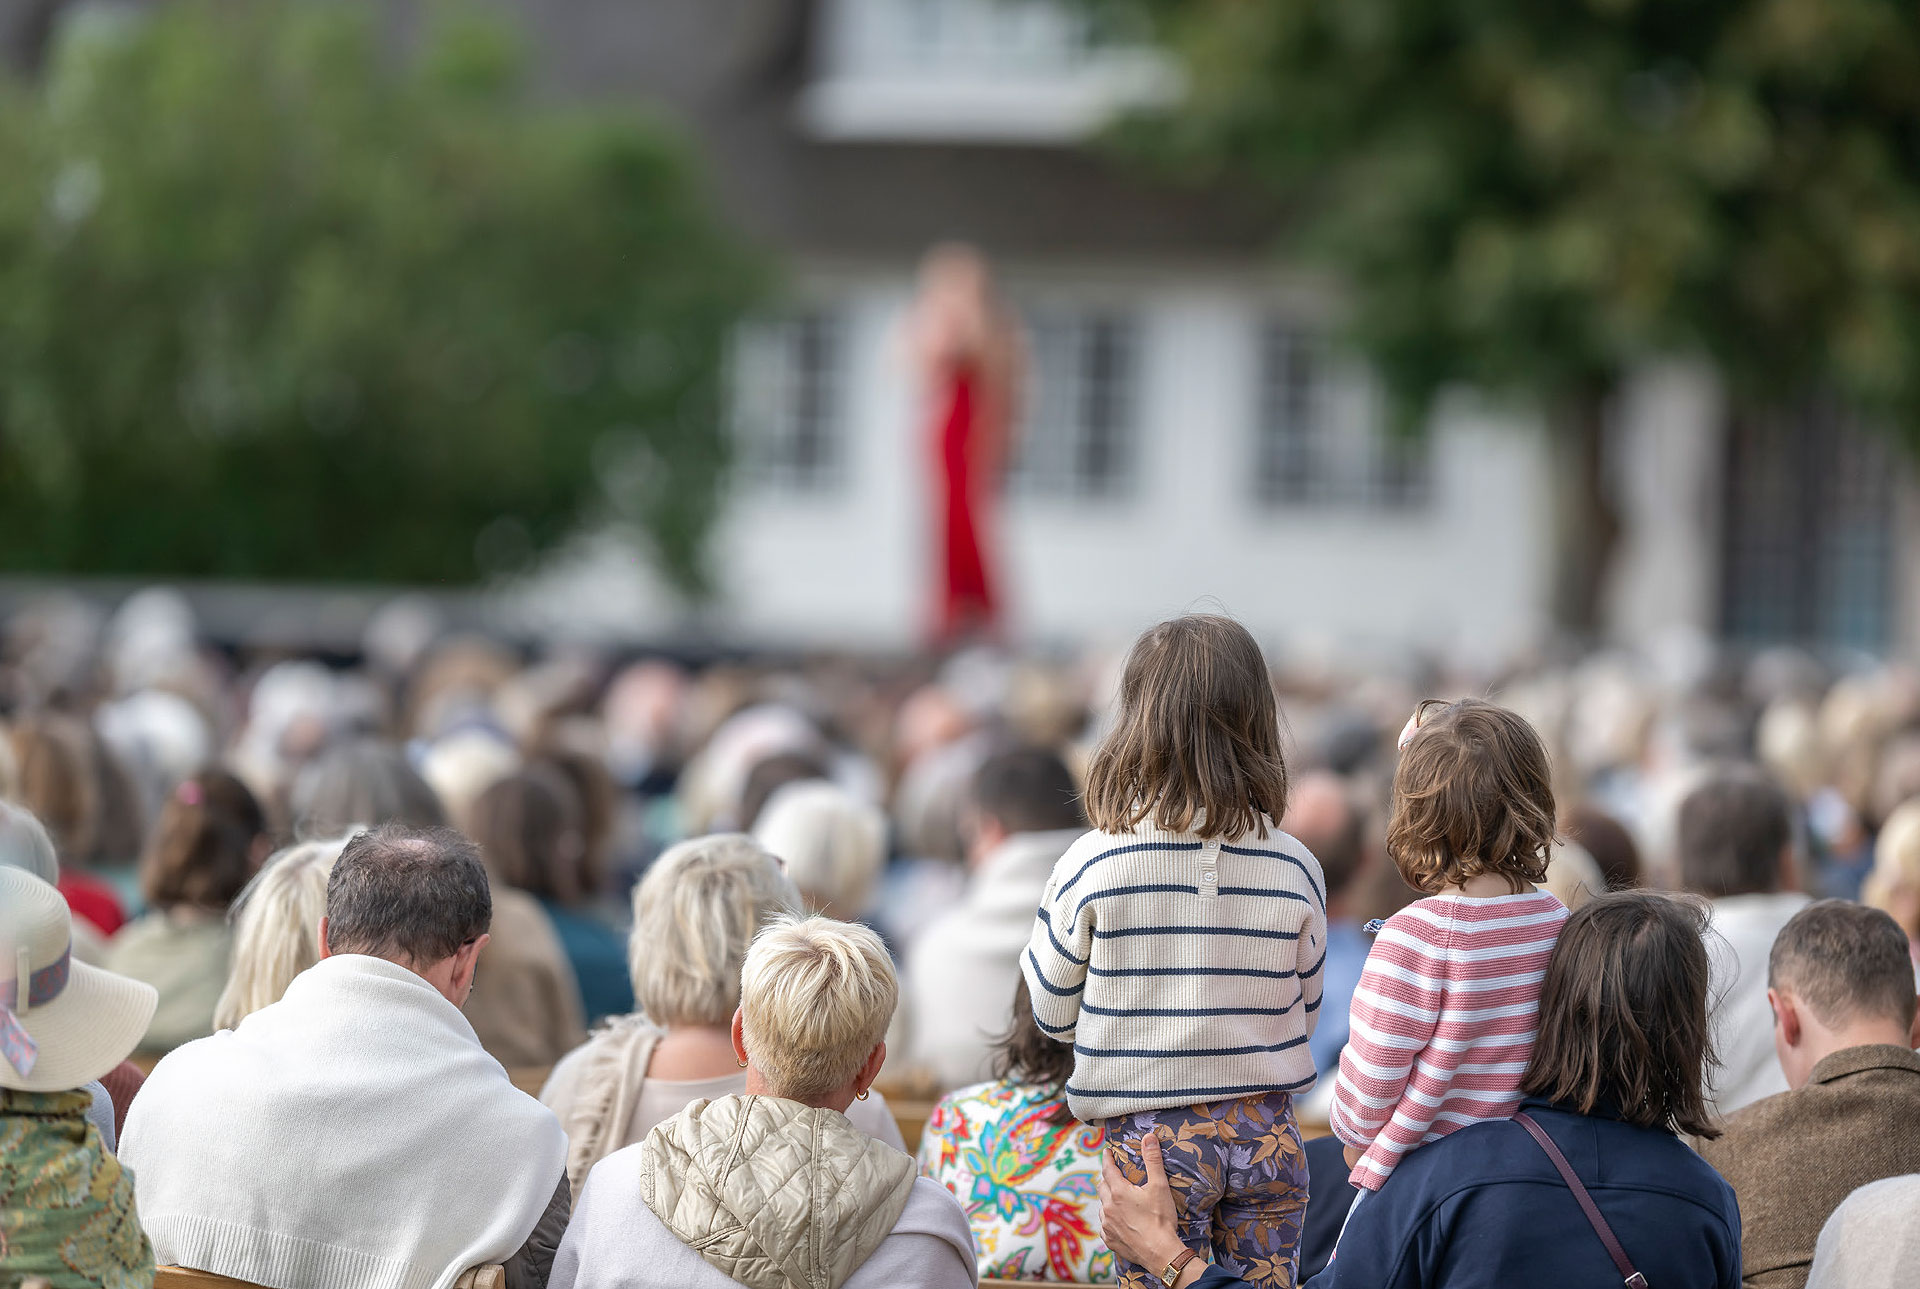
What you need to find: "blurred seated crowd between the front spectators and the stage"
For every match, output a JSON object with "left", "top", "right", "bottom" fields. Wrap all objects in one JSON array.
[{"left": 15, "top": 590, "right": 1920, "bottom": 1087}]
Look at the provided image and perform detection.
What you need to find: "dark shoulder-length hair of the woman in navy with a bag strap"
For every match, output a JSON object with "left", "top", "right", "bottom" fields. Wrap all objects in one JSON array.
[{"left": 1521, "top": 891, "right": 1720, "bottom": 1137}]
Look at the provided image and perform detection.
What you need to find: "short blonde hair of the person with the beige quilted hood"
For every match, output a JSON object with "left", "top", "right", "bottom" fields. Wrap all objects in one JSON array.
[{"left": 739, "top": 918, "right": 900, "bottom": 1101}]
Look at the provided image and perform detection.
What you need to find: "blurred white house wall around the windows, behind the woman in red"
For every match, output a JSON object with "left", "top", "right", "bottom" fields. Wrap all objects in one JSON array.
[{"left": 501, "top": 271, "right": 1743, "bottom": 665}]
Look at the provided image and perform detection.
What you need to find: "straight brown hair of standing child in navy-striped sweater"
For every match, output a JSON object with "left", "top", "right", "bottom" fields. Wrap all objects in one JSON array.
[{"left": 1087, "top": 613, "right": 1286, "bottom": 838}]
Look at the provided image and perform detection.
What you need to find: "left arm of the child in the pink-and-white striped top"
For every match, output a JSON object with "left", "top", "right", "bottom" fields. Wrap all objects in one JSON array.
[{"left": 1327, "top": 912, "right": 1446, "bottom": 1147}]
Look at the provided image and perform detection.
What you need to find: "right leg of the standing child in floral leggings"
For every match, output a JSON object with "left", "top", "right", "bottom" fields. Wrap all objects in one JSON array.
[{"left": 1212, "top": 1093, "right": 1308, "bottom": 1289}]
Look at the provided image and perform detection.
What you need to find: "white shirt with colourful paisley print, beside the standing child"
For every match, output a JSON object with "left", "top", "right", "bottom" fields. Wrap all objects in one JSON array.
[{"left": 920, "top": 1082, "right": 1114, "bottom": 1283}]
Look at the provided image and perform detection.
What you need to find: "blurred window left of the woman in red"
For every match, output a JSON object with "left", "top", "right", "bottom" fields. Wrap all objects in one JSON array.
[{"left": 728, "top": 307, "right": 847, "bottom": 492}]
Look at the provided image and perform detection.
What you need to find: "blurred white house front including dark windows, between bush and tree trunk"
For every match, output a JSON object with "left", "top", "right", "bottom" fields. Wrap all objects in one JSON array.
[{"left": 716, "top": 261, "right": 1549, "bottom": 664}]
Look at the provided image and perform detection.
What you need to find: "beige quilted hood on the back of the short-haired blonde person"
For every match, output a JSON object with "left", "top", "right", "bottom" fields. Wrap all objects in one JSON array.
[{"left": 639, "top": 1097, "right": 914, "bottom": 1289}]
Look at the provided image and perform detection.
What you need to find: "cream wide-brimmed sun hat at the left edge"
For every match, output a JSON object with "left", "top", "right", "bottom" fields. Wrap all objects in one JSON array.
[{"left": 0, "top": 868, "right": 159, "bottom": 1091}]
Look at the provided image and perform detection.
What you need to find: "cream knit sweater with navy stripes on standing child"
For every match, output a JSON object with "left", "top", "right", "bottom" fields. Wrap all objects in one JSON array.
[{"left": 1021, "top": 828, "right": 1327, "bottom": 1122}]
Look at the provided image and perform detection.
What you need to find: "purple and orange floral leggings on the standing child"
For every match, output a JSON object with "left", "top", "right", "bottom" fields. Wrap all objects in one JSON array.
[{"left": 1106, "top": 1093, "right": 1308, "bottom": 1289}]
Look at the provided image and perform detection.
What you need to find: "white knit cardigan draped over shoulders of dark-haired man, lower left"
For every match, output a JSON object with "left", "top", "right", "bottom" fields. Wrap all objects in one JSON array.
[{"left": 121, "top": 955, "right": 566, "bottom": 1289}]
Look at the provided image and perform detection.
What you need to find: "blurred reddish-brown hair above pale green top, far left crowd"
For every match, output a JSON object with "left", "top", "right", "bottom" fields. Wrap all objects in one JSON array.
[{"left": 140, "top": 770, "right": 267, "bottom": 911}]
